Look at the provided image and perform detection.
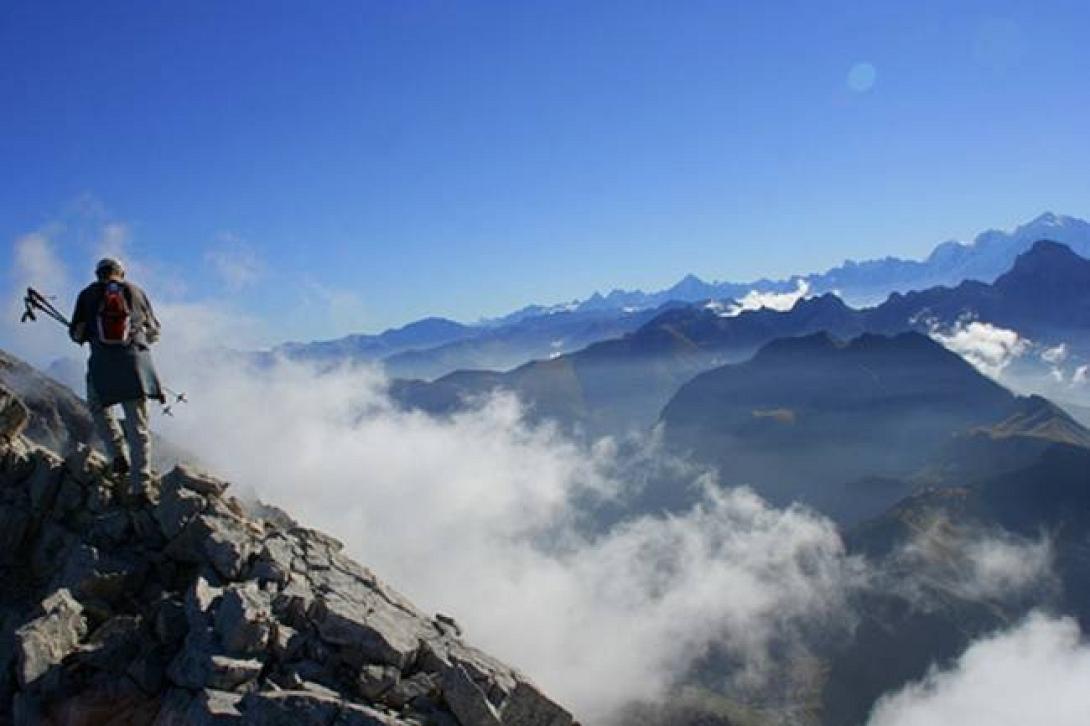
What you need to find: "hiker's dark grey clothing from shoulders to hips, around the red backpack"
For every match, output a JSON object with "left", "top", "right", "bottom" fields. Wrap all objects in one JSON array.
[{"left": 69, "top": 281, "right": 164, "bottom": 406}]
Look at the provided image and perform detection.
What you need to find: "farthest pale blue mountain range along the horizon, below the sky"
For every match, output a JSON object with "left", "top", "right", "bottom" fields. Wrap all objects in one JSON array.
[{"left": 271, "top": 213, "right": 1090, "bottom": 379}]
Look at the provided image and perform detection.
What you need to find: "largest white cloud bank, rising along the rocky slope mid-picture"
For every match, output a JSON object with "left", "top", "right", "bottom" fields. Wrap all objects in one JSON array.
[{"left": 153, "top": 355, "right": 859, "bottom": 723}]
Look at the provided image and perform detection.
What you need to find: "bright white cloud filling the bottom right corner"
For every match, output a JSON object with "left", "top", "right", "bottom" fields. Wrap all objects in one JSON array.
[{"left": 869, "top": 613, "right": 1090, "bottom": 726}]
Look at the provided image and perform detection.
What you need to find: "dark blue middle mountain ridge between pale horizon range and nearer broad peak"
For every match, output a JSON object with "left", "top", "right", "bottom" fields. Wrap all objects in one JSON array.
[{"left": 393, "top": 241, "right": 1090, "bottom": 435}]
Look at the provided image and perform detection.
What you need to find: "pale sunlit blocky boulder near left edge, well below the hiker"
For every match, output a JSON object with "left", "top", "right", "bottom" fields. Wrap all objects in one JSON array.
[{"left": 15, "top": 590, "right": 87, "bottom": 688}]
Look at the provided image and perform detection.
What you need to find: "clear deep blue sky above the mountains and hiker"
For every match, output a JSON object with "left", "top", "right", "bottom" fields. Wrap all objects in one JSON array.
[{"left": 0, "top": 0, "right": 1090, "bottom": 338}]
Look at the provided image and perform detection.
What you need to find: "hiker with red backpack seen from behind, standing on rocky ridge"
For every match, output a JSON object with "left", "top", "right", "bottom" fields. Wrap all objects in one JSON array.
[{"left": 69, "top": 257, "right": 165, "bottom": 499}]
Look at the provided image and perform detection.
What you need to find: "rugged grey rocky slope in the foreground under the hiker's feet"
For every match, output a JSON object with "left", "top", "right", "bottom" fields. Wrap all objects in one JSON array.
[{"left": 0, "top": 389, "right": 572, "bottom": 726}]
